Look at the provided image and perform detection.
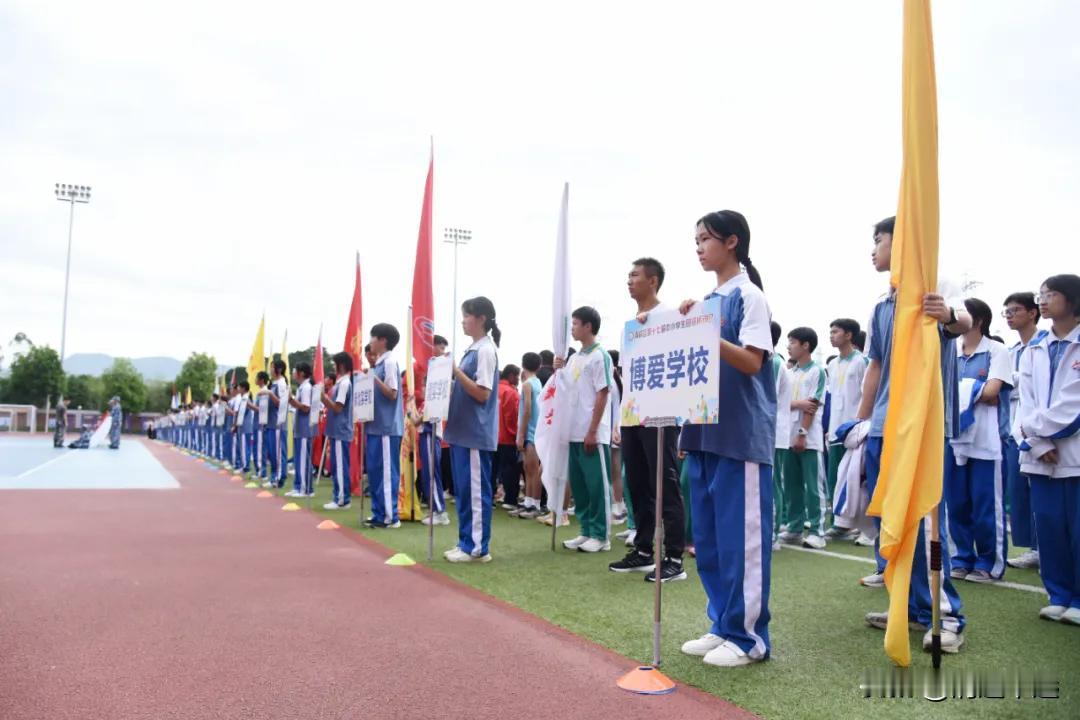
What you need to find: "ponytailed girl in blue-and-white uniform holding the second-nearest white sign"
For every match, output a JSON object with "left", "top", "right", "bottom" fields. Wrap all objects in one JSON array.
[{"left": 444, "top": 297, "right": 502, "bottom": 562}]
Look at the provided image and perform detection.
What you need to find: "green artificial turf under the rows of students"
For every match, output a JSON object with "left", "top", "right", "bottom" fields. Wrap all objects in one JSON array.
[{"left": 232, "top": 464, "right": 1080, "bottom": 720}]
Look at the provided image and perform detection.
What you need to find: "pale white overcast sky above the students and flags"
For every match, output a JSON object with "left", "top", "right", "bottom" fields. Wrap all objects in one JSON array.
[{"left": 0, "top": 0, "right": 1080, "bottom": 371}]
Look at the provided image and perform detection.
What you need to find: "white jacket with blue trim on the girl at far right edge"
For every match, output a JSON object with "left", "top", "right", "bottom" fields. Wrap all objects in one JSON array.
[{"left": 1016, "top": 326, "right": 1080, "bottom": 477}]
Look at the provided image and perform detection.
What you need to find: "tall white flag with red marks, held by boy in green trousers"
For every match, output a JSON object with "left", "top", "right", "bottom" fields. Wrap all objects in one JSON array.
[{"left": 536, "top": 182, "right": 571, "bottom": 511}]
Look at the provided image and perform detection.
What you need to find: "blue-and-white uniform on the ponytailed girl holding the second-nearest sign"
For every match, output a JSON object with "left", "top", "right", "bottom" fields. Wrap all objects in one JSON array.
[{"left": 445, "top": 336, "right": 499, "bottom": 557}]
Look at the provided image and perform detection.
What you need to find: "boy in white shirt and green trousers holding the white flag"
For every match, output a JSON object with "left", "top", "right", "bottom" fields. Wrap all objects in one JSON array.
[{"left": 555, "top": 307, "right": 613, "bottom": 553}]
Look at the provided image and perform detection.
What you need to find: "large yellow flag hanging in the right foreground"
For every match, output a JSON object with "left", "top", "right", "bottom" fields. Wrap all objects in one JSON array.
[{"left": 867, "top": 0, "right": 945, "bottom": 667}]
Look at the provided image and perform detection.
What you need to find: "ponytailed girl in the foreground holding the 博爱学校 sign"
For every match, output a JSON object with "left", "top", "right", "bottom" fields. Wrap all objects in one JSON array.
[{"left": 679, "top": 210, "right": 777, "bottom": 667}]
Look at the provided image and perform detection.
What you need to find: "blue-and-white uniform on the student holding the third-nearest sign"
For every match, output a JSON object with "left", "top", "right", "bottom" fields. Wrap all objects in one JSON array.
[{"left": 364, "top": 352, "right": 405, "bottom": 525}]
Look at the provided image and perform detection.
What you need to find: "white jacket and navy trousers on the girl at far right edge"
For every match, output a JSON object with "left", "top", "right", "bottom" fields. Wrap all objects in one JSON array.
[{"left": 1015, "top": 326, "right": 1080, "bottom": 609}]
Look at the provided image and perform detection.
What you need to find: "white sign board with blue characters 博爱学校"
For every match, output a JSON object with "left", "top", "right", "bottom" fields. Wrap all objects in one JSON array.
[{"left": 620, "top": 298, "right": 720, "bottom": 426}]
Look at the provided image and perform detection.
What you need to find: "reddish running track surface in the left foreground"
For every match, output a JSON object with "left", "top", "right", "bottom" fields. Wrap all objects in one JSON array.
[{"left": 0, "top": 443, "right": 754, "bottom": 720}]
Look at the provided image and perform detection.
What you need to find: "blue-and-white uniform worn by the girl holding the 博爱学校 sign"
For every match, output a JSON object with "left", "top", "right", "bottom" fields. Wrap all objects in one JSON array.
[{"left": 678, "top": 273, "right": 777, "bottom": 660}]
